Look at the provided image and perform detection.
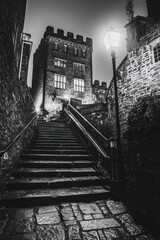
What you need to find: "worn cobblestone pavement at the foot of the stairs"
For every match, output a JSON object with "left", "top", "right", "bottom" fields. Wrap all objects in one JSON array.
[{"left": 0, "top": 200, "right": 158, "bottom": 240}]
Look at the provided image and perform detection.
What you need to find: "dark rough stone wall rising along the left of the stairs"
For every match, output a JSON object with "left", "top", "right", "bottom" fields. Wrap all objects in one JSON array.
[{"left": 0, "top": 0, "right": 33, "bottom": 182}]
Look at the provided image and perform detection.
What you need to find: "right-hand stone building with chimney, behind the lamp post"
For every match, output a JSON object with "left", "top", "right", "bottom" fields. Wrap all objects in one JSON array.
[{"left": 107, "top": 0, "right": 160, "bottom": 138}]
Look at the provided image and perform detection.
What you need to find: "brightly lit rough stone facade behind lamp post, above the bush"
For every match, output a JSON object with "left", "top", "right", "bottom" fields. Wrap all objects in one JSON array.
[{"left": 107, "top": 18, "right": 160, "bottom": 139}]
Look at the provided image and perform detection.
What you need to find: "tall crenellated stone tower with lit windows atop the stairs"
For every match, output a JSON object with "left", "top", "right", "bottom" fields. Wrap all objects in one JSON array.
[{"left": 32, "top": 26, "right": 93, "bottom": 111}]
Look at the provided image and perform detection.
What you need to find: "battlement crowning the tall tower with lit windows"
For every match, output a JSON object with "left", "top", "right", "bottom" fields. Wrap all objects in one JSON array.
[{"left": 44, "top": 26, "right": 93, "bottom": 47}]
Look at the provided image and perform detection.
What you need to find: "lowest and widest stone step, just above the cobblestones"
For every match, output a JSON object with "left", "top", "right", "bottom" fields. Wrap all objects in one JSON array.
[{"left": 0, "top": 186, "right": 109, "bottom": 208}]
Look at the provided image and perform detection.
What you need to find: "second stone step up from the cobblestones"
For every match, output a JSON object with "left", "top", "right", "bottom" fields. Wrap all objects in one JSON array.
[{"left": 5, "top": 176, "right": 107, "bottom": 191}]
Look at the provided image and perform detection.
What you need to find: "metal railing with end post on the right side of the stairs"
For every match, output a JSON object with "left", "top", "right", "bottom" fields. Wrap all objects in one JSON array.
[{"left": 64, "top": 104, "right": 119, "bottom": 199}]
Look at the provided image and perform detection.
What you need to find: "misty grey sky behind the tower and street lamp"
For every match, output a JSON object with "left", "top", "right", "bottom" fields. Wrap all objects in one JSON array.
[{"left": 24, "top": 0, "right": 147, "bottom": 86}]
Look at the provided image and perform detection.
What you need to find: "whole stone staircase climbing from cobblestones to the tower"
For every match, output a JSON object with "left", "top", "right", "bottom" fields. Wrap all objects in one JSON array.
[{"left": 1, "top": 119, "right": 109, "bottom": 207}]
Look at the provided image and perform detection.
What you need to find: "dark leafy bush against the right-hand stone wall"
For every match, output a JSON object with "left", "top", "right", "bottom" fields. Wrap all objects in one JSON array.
[{"left": 125, "top": 95, "right": 160, "bottom": 146}]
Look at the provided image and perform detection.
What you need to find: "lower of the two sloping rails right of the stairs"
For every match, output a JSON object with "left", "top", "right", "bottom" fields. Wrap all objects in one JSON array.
[{"left": 64, "top": 109, "right": 109, "bottom": 158}]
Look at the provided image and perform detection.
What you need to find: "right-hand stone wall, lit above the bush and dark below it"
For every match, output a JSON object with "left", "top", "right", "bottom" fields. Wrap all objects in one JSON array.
[{"left": 104, "top": 16, "right": 160, "bottom": 236}]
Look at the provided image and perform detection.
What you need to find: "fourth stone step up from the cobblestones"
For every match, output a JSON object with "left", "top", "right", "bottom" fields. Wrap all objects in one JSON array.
[{"left": 17, "top": 160, "right": 93, "bottom": 168}]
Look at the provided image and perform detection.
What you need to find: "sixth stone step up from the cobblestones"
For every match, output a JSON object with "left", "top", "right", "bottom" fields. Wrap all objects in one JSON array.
[{"left": 24, "top": 148, "right": 87, "bottom": 154}]
